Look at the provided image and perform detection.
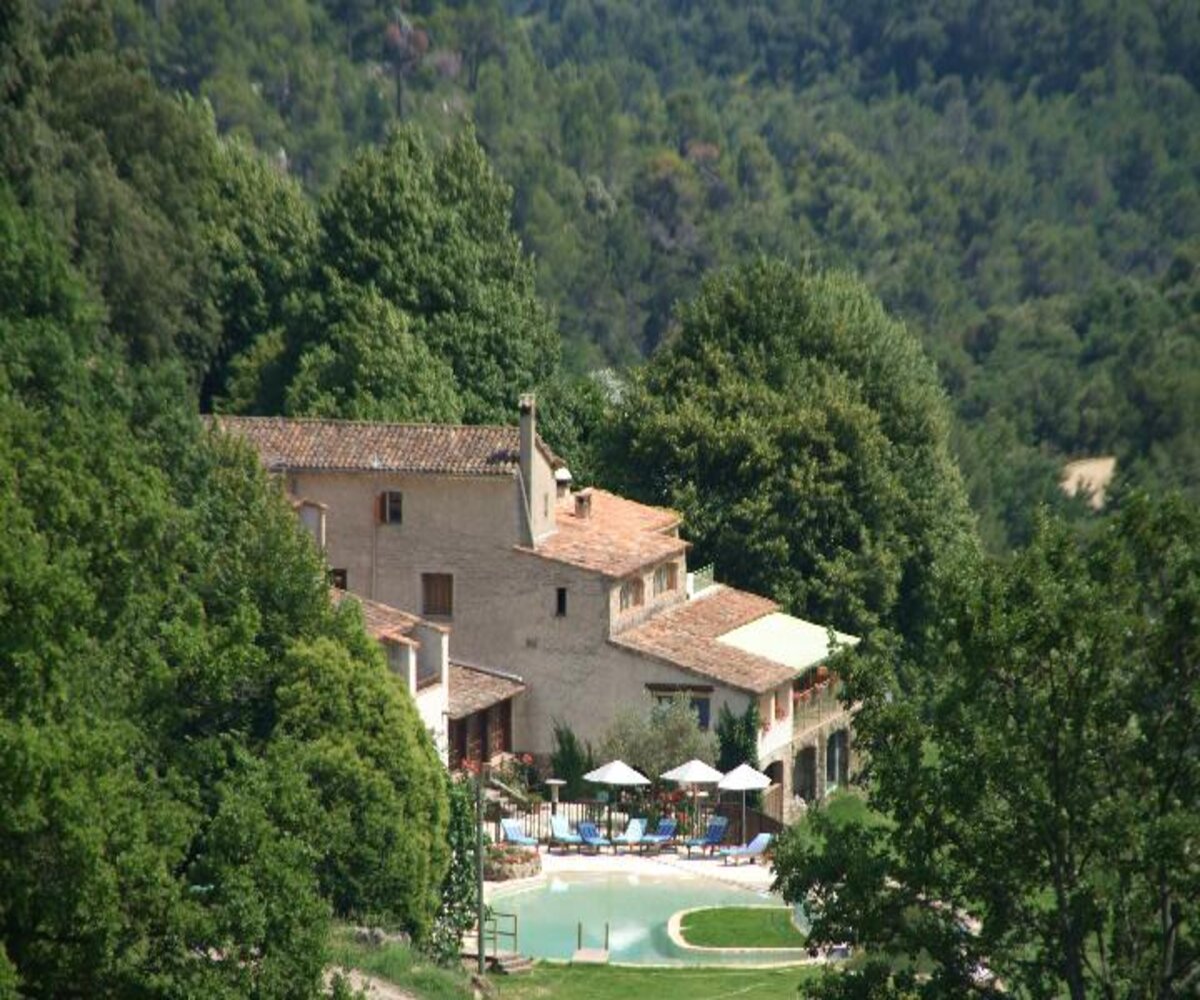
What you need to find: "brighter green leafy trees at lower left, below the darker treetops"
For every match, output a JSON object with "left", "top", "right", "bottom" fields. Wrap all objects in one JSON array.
[{"left": 0, "top": 185, "right": 446, "bottom": 998}]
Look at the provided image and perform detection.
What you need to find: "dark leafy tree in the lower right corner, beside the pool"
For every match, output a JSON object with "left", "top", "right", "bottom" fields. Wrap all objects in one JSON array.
[{"left": 776, "top": 496, "right": 1200, "bottom": 998}]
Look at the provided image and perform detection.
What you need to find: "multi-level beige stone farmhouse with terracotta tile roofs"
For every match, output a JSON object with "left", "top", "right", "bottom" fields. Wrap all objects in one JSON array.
[{"left": 214, "top": 396, "right": 857, "bottom": 819}]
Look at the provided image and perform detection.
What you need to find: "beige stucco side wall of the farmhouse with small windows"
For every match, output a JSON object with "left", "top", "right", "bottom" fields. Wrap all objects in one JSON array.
[{"left": 289, "top": 468, "right": 748, "bottom": 755}]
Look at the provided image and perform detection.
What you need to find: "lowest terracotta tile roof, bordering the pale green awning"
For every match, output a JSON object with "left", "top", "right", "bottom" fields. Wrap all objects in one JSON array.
[{"left": 608, "top": 585, "right": 799, "bottom": 694}]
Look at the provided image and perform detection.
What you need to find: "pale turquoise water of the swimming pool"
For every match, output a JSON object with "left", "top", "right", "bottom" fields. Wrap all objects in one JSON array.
[{"left": 490, "top": 873, "right": 799, "bottom": 965}]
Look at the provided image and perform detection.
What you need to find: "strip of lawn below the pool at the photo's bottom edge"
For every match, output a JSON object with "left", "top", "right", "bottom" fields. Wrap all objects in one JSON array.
[{"left": 492, "top": 964, "right": 821, "bottom": 1000}]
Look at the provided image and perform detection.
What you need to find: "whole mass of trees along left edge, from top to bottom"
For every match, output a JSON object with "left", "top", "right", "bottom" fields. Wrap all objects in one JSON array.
[{"left": 0, "top": 13, "right": 446, "bottom": 984}]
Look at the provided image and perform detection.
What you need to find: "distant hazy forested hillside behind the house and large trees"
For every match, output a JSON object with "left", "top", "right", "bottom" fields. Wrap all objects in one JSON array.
[{"left": 110, "top": 0, "right": 1200, "bottom": 541}]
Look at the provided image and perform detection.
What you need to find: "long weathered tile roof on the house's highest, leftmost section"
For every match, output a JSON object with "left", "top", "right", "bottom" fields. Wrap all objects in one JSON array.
[{"left": 209, "top": 417, "right": 562, "bottom": 475}]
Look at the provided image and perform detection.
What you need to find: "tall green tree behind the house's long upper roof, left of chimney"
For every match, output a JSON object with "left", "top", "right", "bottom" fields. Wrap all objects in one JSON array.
[{"left": 282, "top": 127, "right": 558, "bottom": 423}]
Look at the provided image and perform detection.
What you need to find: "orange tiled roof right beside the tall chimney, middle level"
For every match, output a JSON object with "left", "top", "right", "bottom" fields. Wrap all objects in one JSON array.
[{"left": 526, "top": 489, "right": 688, "bottom": 579}]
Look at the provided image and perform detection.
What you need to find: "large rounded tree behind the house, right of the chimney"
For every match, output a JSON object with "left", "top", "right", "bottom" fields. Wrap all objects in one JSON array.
[{"left": 606, "top": 259, "right": 972, "bottom": 637}]
